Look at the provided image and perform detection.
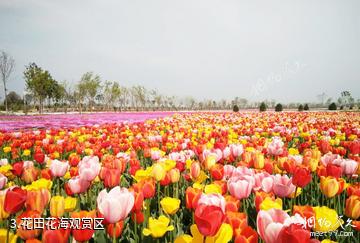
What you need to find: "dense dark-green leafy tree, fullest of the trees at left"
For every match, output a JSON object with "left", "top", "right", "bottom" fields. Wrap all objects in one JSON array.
[{"left": 24, "top": 63, "right": 58, "bottom": 113}]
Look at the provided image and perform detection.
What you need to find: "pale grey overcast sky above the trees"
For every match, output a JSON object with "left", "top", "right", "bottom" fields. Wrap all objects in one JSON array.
[{"left": 0, "top": 0, "right": 360, "bottom": 102}]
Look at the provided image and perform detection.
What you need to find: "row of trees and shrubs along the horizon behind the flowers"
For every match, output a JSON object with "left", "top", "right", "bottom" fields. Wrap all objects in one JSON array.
[{"left": 0, "top": 51, "right": 360, "bottom": 113}]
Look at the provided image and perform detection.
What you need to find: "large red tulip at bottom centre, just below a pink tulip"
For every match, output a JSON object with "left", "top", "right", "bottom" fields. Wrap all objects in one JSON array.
[{"left": 195, "top": 204, "right": 225, "bottom": 236}]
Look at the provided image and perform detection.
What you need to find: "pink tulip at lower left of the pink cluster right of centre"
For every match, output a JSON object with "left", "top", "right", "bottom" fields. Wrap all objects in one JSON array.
[{"left": 227, "top": 175, "right": 254, "bottom": 199}]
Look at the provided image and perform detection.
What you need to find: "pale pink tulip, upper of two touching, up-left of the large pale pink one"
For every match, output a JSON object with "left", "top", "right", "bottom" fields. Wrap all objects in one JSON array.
[{"left": 78, "top": 156, "right": 101, "bottom": 181}]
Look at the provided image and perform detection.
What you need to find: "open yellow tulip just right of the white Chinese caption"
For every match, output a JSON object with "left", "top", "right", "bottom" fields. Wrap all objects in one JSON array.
[{"left": 143, "top": 215, "right": 174, "bottom": 238}]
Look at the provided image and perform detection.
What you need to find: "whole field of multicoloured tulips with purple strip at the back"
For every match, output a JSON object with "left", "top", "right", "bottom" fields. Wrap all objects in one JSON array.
[{"left": 0, "top": 111, "right": 360, "bottom": 243}]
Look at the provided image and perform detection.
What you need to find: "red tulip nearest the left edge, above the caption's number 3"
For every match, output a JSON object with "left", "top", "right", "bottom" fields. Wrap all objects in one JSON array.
[{"left": 4, "top": 187, "right": 27, "bottom": 214}]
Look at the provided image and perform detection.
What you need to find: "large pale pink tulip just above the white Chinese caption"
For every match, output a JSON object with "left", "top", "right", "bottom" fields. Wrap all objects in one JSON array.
[{"left": 97, "top": 186, "right": 135, "bottom": 224}]
